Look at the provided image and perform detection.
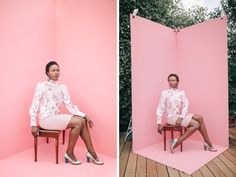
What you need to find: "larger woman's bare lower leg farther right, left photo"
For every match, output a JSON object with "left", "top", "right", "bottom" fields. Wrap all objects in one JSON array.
[{"left": 80, "top": 120, "right": 98, "bottom": 159}]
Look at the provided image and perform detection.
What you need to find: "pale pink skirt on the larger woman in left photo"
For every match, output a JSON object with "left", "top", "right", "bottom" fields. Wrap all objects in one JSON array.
[{"left": 39, "top": 114, "right": 74, "bottom": 130}]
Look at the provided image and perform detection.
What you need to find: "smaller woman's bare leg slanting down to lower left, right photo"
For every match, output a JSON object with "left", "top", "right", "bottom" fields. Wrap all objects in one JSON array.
[{"left": 174, "top": 119, "right": 200, "bottom": 148}]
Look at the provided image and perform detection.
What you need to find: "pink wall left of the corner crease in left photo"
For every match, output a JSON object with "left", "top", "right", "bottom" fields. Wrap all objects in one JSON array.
[{"left": 0, "top": 0, "right": 55, "bottom": 159}]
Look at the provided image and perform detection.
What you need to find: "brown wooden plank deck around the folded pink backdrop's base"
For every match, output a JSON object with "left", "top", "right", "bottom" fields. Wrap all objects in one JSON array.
[{"left": 119, "top": 127, "right": 236, "bottom": 177}]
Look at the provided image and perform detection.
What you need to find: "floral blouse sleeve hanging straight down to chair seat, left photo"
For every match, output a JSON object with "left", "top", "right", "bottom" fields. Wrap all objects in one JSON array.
[{"left": 29, "top": 83, "right": 43, "bottom": 126}]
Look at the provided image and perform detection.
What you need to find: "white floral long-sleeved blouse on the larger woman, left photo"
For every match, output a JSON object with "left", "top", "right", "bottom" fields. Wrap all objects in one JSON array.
[{"left": 29, "top": 80, "right": 85, "bottom": 126}]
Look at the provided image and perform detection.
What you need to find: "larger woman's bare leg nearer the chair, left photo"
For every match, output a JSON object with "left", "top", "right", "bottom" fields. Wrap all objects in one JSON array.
[{"left": 66, "top": 116, "right": 83, "bottom": 160}]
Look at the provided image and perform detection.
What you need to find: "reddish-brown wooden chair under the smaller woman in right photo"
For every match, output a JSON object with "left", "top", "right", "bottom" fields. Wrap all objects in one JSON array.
[{"left": 163, "top": 124, "right": 186, "bottom": 152}]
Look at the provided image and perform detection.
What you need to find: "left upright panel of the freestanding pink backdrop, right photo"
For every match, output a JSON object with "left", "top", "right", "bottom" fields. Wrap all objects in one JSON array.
[{"left": 130, "top": 16, "right": 176, "bottom": 150}]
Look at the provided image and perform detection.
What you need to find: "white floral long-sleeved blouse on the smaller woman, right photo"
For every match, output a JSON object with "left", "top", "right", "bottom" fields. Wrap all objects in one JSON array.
[{"left": 156, "top": 88, "right": 189, "bottom": 124}]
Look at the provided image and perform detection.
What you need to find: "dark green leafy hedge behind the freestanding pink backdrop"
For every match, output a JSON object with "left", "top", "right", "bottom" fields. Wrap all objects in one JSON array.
[{"left": 119, "top": 0, "right": 231, "bottom": 132}]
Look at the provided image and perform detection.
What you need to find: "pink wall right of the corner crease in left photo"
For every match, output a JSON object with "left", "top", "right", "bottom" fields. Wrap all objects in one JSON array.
[{"left": 56, "top": 0, "right": 116, "bottom": 156}]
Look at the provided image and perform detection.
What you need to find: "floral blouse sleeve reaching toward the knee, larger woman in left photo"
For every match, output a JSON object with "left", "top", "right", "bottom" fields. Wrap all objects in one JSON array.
[{"left": 62, "top": 85, "right": 86, "bottom": 118}]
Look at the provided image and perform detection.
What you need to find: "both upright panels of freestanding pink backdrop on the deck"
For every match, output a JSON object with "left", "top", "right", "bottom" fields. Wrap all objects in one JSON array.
[{"left": 131, "top": 17, "right": 228, "bottom": 151}]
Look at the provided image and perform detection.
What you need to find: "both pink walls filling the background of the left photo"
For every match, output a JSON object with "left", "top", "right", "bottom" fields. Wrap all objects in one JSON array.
[{"left": 0, "top": 0, "right": 116, "bottom": 159}]
